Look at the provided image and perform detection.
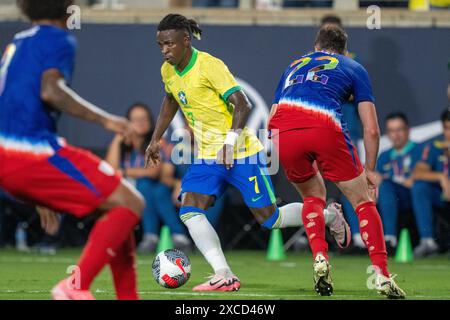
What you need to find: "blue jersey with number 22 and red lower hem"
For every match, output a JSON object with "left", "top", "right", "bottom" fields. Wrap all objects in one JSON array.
[{"left": 269, "top": 51, "right": 374, "bottom": 132}]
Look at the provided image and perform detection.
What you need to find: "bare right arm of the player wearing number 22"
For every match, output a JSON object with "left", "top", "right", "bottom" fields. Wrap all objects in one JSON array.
[{"left": 358, "top": 101, "right": 380, "bottom": 171}]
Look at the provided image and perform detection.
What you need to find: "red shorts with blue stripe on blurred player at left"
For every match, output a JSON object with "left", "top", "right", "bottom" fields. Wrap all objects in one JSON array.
[{"left": 0, "top": 145, "right": 121, "bottom": 217}]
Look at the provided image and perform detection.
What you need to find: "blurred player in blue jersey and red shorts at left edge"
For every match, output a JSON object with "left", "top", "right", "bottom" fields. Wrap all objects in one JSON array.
[{"left": 0, "top": 0, "right": 144, "bottom": 300}]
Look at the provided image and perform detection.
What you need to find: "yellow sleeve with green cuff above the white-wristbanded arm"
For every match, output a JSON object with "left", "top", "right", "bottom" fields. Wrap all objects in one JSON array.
[{"left": 203, "top": 57, "right": 241, "bottom": 101}]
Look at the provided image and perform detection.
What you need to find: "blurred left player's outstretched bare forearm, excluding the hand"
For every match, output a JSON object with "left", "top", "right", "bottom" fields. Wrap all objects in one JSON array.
[{"left": 41, "top": 69, "right": 113, "bottom": 126}]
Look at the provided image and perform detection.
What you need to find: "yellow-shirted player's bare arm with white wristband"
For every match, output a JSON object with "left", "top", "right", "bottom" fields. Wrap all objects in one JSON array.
[{"left": 217, "top": 90, "right": 252, "bottom": 169}]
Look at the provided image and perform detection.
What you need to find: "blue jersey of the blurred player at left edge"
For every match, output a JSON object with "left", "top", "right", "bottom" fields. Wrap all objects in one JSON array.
[{"left": 0, "top": 25, "right": 76, "bottom": 153}]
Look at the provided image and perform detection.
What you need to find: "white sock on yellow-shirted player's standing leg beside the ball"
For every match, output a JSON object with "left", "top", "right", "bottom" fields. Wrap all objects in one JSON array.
[{"left": 184, "top": 214, "right": 231, "bottom": 275}]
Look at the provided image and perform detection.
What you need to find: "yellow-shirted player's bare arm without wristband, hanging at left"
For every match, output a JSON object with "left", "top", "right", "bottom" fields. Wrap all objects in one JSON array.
[{"left": 145, "top": 95, "right": 178, "bottom": 168}]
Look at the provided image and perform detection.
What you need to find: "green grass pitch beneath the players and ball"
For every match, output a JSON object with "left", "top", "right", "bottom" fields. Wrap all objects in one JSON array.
[{"left": 0, "top": 250, "right": 450, "bottom": 300}]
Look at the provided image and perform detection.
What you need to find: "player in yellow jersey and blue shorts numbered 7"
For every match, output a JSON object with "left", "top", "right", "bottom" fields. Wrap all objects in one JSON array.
[{"left": 146, "top": 14, "right": 350, "bottom": 291}]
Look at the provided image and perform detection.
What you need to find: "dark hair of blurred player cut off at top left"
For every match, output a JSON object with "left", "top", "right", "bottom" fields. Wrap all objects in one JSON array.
[{"left": 17, "top": 0, "right": 74, "bottom": 21}]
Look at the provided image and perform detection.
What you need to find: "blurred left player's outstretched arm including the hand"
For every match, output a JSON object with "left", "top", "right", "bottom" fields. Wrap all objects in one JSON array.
[{"left": 40, "top": 69, "right": 133, "bottom": 142}]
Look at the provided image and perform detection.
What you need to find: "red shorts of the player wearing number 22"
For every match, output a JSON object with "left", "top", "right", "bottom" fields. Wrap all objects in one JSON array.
[{"left": 272, "top": 127, "right": 363, "bottom": 183}]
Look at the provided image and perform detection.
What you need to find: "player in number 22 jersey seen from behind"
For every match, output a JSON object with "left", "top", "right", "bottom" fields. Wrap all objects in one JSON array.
[{"left": 269, "top": 25, "right": 405, "bottom": 298}]
